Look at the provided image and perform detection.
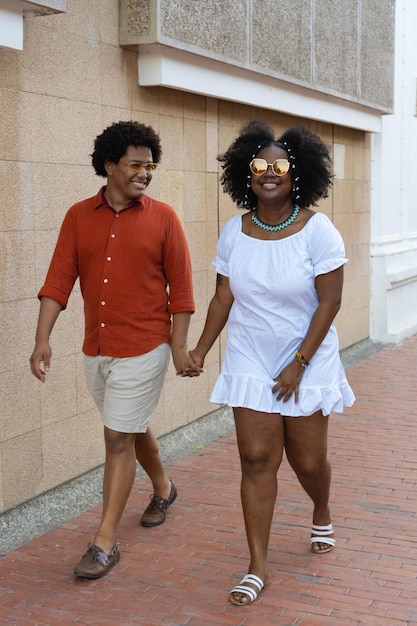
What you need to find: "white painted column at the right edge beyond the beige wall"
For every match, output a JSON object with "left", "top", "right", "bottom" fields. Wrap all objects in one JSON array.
[{"left": 371, "top": 0, "right": 417, "bottom": 343}]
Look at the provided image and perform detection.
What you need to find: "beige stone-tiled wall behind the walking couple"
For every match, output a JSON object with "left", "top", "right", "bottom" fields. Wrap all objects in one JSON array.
[{"left": 0, "top": 0, "right": 376, "bottom": 512}]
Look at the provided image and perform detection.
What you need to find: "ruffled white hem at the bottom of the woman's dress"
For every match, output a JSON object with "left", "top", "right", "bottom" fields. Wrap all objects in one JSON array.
[{"left": 210, "top": 374, "right": 355, "bottom": 417}]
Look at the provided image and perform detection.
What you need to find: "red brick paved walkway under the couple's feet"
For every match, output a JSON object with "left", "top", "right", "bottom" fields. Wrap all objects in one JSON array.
[{"left": 0, "top": 336, "right": 417, "bottom": 626}]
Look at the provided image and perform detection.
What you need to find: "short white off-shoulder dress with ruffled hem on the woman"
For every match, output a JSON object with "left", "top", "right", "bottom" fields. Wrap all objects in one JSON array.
[{"left": 210, "top": 213, "right": 355, "bottom": 417}]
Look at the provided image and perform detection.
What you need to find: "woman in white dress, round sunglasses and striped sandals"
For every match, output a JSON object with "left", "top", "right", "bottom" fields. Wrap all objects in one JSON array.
[{"left": 191, "top": 120, "right": 354, "bottom": 606}]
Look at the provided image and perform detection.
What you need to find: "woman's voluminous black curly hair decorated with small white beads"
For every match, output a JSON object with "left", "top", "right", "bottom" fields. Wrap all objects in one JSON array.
[{"left": 217, "top": 120, "right": 332, "bottom": 210}]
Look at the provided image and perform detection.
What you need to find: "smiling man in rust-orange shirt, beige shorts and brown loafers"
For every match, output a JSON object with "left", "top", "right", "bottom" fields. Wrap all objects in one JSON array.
[{"left": 30, "top": 121, "right": 201, "bottom": 578}]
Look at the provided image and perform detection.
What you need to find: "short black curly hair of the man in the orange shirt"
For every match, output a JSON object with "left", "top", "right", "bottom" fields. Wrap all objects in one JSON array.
[{"left": 91, "top": 121, "right": 162, "bottom": 178}]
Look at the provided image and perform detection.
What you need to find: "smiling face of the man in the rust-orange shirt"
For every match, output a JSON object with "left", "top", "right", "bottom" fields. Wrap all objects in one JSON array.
[{"left": 105, "top": 146, "right": 152, "bottom": 210}]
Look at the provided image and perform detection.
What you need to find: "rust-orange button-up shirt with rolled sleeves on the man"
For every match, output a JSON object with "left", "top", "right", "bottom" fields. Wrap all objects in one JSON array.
[{"left": 38, "top": 189, "right": 194, "bottom": 357}]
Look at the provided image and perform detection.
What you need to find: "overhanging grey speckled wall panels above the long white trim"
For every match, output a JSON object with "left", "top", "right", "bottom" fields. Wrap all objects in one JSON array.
[{"left": 120, "top": 0, "right": 395, "bottom": 113}]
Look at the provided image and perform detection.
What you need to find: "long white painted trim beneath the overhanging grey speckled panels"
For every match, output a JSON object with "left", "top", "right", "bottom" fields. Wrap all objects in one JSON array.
[{"left": 139, "top": 44, "right": 382, "bottom": 133}]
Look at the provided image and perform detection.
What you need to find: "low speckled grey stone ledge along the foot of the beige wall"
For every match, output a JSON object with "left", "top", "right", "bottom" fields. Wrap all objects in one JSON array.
[{"left": 0, "top": 340, "right": 384, "bottom": 556}]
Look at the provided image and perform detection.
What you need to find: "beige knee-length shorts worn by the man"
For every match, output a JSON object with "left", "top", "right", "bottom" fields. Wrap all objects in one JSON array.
[{"left": 84, "top": 343, "right": 171, "bottom": 433}]
